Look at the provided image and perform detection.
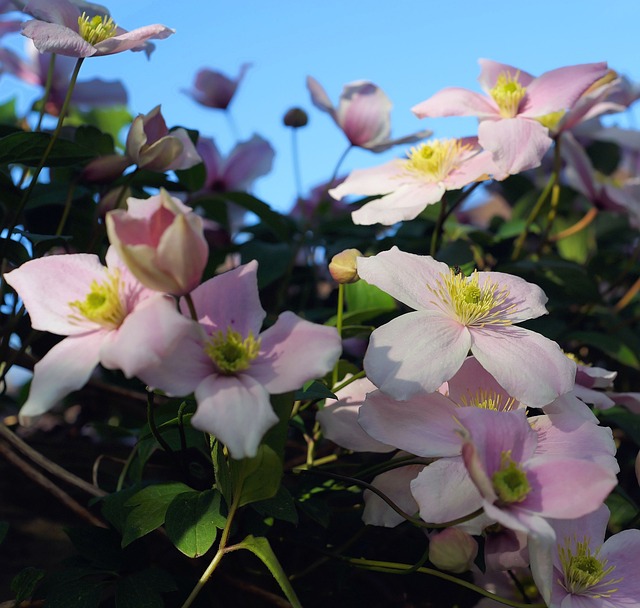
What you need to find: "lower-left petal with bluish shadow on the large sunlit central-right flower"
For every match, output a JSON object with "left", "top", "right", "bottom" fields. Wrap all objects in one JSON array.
[{"left": 364, "top": 311, "right": 471, "bottom": 400}]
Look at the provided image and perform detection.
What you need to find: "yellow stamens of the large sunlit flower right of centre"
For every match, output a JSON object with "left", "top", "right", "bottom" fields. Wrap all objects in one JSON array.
[{"left": 427, "top": 270, "right": 515, "bottom": 327}]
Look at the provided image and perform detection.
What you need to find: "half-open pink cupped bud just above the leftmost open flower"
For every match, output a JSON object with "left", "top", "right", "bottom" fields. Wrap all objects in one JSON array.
[{"left": 106, "top": 190, "right": 209, "bottom": 295}]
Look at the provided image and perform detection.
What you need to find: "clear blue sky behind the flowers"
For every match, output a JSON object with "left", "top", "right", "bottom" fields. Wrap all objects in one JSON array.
[{"left": 0, "top": 0, "right": 640, "bottom": 211}]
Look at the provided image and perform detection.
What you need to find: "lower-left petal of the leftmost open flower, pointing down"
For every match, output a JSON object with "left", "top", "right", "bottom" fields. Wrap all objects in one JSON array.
[{"left": 20, "top": 332, "right": 107, "bottom": 424}]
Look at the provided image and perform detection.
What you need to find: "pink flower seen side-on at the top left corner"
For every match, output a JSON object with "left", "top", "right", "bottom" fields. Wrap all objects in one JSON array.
[{"left": 22, "top": 0, "right": 175, "bottom": 57}]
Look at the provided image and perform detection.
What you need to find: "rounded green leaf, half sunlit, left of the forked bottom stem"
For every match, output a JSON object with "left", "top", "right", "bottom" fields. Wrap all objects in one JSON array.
[{"left": 165, "top": 490, "right": 227, "bottom": 557}]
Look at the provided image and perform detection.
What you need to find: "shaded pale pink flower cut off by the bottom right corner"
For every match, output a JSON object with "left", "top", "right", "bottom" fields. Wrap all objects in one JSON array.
[{"left": 531, "top": 505, "right": 640, "bottom": 608}]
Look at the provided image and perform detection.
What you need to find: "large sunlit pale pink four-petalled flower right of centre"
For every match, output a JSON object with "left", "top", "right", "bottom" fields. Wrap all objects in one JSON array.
[{"left": 358, "top": 247, "right": 576, "bottom": 407}]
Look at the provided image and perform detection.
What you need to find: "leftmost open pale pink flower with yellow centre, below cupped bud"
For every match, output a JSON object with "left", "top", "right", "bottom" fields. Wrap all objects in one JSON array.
[{"left": 4, "top": 248, "right": 179, "bottom": 422}]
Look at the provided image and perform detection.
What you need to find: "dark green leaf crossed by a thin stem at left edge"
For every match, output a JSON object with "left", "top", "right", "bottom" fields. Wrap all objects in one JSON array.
[{"left": 0, "top": 132, "right": 95, "bottom": 167}]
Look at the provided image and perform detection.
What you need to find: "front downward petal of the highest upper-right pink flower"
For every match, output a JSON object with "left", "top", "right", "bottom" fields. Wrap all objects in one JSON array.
[{"left": 478, "top": 118, "right": 553, "bottom": 175}]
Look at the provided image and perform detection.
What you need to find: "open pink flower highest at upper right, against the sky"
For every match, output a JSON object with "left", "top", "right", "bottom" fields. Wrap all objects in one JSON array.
[{"left": 413, "top": 59, "right": 607, "bottom": 174}]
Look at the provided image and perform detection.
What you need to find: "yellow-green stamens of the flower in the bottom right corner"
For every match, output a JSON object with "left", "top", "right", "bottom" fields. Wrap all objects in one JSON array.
[{"left": 558, "top": 537, "right": 623, "bottom": 598}]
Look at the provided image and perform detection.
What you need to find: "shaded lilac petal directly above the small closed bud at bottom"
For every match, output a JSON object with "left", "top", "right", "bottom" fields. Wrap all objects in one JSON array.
[{"left": 411, "top": 457, "right": 482, "bottom": 523}]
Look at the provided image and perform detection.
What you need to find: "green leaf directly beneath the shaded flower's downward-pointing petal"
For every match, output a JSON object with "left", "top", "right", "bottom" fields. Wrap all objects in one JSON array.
[{"left": 230, "top": 443, "right": 282, "bottom": 507}]
